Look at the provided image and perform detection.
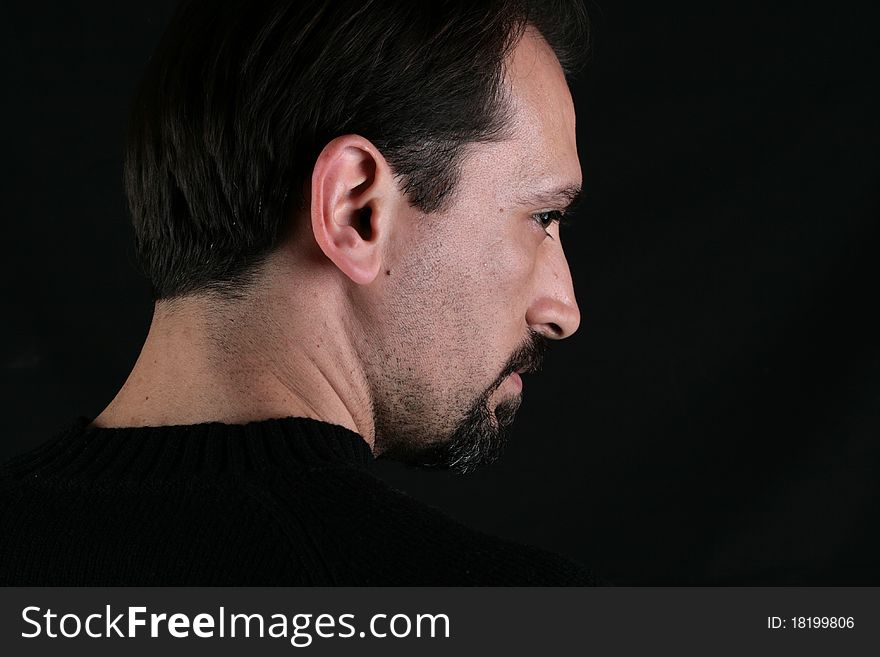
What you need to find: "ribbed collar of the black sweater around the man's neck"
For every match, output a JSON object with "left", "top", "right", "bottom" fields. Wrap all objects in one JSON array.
[{"left": 10, "top": 417, "right": 373, "bottom": 479}]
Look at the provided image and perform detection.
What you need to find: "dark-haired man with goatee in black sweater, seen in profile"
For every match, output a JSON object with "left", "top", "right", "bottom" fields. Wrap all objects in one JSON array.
[{"left": 0, "top": 0, "right": 593, "bottom": 585}]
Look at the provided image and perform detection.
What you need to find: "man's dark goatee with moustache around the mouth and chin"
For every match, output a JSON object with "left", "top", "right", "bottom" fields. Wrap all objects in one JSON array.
[{"left": 374, "top": 330, "right": 547, "bottom": 474}]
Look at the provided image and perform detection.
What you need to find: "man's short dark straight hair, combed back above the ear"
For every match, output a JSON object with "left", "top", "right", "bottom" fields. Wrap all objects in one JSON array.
[{"left": 125, "top": 0, "right": 586, "bottom": 300}]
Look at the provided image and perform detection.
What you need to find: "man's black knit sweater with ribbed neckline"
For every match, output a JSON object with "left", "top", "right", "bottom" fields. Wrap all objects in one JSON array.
[{"left": 0, "top": 418, "right": 594, "bottom": 586}]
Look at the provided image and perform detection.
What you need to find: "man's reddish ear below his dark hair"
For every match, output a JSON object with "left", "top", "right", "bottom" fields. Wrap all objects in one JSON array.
[{"left": 310, "top": 135, "right": 396, "bottom": 285}]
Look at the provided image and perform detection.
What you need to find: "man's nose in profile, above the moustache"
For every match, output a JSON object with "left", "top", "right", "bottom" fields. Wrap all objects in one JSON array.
[{"left": 526, "top": 242, "right": 581, "bottom": 340}]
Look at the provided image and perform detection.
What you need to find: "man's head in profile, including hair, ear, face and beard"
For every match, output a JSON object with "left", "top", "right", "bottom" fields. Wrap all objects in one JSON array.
[{"left": 126, "top": 0, "right": 583, "bottom": 470}]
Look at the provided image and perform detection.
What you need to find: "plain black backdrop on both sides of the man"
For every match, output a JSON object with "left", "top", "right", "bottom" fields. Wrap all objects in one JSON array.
[{"left": 0, "top": 0, "right": 880, "bottom": 584}]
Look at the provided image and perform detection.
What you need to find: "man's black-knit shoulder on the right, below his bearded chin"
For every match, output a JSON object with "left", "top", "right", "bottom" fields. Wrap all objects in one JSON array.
[{"left": 268, "top": 469, "right": 595, "bottom": 586}]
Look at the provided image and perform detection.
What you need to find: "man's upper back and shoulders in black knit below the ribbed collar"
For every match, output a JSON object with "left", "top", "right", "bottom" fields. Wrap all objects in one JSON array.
[{"left": 0, "top": 438, "right": 593, "bottom": 586}]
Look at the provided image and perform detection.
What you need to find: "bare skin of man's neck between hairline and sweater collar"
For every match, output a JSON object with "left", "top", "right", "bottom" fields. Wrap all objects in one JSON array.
[{"left": 93, "top": 290, "right": 373, "bottom": 446}]
